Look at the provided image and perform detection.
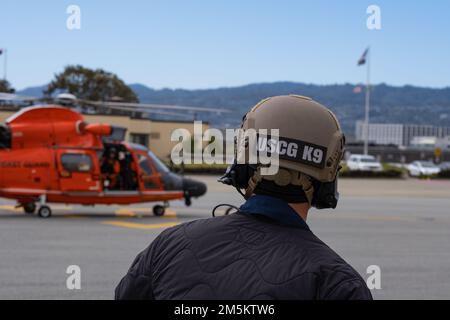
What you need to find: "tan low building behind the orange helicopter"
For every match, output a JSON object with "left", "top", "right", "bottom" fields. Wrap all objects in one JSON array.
[{"left": 0, "top": 110, "right": 209, "bottom": 160}]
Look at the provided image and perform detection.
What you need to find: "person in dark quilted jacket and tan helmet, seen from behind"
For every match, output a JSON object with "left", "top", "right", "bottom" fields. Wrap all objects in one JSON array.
[{"left": 116, "top": 96, "right": 372, "bottom": 300}]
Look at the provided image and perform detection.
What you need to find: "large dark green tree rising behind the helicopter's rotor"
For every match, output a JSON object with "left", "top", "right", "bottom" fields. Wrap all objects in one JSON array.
[{"left": 44, "top": 65, "right": 139, "bottom": 102}]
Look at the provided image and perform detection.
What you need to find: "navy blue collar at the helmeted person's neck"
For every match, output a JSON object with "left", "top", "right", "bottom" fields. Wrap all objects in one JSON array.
[{"left": 239, "top": 194, "right": 309, "bottom": 230}]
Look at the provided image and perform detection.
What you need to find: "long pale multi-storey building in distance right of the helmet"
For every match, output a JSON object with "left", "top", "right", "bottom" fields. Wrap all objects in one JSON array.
[{"left": 355, "top": 121, "right": 450, "bottom": 147}]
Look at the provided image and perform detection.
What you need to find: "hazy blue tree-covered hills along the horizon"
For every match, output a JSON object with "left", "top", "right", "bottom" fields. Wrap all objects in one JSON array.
[{"left": 18, "top": 82, "right": 450, "bottom": 134}]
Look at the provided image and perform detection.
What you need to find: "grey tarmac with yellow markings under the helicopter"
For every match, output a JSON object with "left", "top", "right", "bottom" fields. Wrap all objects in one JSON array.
[{"left": 0, "top": 176, "right": 450, "bottom": 299}]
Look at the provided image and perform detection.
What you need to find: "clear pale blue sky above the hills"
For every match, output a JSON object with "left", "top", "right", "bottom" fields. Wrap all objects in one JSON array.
[{"left": 0, "top": 0, "right": 450, "bottom": 89}]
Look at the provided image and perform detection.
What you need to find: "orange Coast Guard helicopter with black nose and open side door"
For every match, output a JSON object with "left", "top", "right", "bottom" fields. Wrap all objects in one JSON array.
[{"left": 0, "top": 105, "right": 206, "bottom": 218}]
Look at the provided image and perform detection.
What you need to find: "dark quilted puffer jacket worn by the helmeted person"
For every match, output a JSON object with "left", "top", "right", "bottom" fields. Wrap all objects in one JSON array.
[{"left": 116, "top": 195, "right": 372, "bottom": 299}]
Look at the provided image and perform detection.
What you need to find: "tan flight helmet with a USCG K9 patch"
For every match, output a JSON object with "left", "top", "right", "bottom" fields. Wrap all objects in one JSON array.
[{"left": 238, "top": 95, "right": 345, "bottom": 204}]
